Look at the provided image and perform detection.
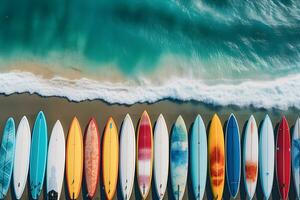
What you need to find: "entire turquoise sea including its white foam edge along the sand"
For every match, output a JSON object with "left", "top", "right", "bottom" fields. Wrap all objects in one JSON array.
[{"left": 0, "top": 0, "right": 300, "bottom": 109}]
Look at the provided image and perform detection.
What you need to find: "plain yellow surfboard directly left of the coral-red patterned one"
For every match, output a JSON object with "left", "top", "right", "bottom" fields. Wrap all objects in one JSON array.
[{"left": 66, "top": 117, "right": 83, "bottom": 199}]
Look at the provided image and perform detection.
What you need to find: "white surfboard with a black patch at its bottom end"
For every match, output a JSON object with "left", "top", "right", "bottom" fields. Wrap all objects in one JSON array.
[{"left": 46, "top": 120, "right": 65, "bottom": 200}]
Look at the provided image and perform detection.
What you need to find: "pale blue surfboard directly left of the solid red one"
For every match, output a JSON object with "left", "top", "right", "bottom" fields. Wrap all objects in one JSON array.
[{"left": 259, "top": 115, "right": 275, "bottom": 199}]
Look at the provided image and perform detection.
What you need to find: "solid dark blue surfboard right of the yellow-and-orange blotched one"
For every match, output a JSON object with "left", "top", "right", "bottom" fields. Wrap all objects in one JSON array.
[{"left": 225, "top": 114, "right": 241, "bottom": 198}]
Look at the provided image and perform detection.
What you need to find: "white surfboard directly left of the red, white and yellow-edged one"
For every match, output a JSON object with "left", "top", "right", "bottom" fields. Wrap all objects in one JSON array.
[{"left": 119, "top": 114, "right": 136, "bottom": 200}]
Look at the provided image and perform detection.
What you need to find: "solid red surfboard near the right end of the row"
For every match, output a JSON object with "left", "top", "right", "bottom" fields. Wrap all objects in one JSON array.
[{"left": 276, "top": 117, "right": 291, "bottom": 200}]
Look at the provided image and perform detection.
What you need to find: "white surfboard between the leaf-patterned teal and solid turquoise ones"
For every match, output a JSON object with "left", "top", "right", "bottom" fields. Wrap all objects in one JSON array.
[{"left": 13, "top": 116, "right": 31, "bottom": 199}]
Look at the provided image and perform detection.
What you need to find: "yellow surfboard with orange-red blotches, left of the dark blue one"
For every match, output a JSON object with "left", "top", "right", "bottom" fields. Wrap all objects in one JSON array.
[{"left": 208, "top": 114, "right": 225, "bottom": 200}]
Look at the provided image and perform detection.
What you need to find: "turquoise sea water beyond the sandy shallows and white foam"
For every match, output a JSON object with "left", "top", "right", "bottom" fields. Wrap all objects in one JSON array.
[{"left": 0, "top": 0, "right": 300, "bottom": 79}]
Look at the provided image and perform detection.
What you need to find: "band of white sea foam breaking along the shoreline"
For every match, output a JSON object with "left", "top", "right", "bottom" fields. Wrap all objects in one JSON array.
[{"left": 0, "top": 72, "right": 300, "bottom": 109}]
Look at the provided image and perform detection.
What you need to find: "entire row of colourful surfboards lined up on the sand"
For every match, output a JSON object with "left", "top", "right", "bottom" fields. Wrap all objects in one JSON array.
[{"left": 0, "top": 111, "right": 300, "bottom": 200}]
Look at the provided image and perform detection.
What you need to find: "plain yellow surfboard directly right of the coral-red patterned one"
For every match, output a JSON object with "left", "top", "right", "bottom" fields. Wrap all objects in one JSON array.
[{"left": 102, "top": 117, "right": 119, "bottom": 200}]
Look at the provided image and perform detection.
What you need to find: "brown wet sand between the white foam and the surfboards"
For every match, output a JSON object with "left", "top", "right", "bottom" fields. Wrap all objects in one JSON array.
[{"left": 0, "top": 94, "right": 300, "bottom": 199}]
